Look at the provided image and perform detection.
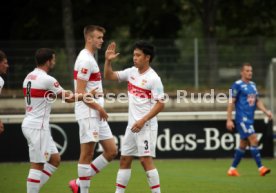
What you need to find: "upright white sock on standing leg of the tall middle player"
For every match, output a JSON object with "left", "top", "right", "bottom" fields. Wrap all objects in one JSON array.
[{"left": 78, "top": 164, "right": 92, "bottom": 193}]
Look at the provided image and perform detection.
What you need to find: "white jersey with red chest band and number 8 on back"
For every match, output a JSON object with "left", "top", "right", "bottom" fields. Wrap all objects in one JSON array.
[{"left": 22, "top": 68, "right": 63, "bottom": 129}]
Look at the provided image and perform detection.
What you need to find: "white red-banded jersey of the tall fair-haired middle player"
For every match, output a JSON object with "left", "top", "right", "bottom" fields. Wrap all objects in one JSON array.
[{"left": 74, "top": 49, "right": 104, "bottom": 120}]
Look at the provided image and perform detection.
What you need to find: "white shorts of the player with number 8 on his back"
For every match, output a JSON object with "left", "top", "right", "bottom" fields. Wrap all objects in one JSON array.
[{"left": 22, "top": 127, "right": 58, "bottom": 163}]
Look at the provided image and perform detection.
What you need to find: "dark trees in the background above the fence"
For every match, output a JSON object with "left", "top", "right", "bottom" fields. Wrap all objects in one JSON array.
[{"left": 0, "top": 0, "right": 276, "bottom": 86}]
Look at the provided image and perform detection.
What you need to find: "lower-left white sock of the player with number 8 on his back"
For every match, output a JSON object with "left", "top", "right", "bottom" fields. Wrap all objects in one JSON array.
[{"left": 27, "top": 169, "right": 42, "bottom": 193}]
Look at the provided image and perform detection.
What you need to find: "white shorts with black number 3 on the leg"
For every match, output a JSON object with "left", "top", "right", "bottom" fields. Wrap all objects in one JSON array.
[{"left": 121, "top": 125, "right": 158, "bottom": 157}]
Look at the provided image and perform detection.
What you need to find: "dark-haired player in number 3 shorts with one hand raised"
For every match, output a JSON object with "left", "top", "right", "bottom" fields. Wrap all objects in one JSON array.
[{"left": 104, "top": 41, "right": 164, "bottom": 193}]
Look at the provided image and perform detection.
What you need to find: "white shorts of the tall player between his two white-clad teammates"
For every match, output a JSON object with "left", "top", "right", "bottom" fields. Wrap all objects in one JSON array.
[{"left": 78, "top": 117, "right": 113, "bottom": 144}]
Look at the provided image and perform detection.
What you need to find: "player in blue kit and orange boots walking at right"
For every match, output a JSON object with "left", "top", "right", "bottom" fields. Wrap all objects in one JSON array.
[{"left": 226, "top": 63, "right": 272, "bottom": 176}]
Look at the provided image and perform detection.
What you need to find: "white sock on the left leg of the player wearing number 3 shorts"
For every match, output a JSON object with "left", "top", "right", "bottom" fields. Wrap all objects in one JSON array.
[{"left": 115, "top": 169, "right": 131, "bottom": 193}]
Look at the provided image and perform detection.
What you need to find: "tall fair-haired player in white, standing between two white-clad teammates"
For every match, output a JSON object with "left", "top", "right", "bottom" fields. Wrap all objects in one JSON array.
[{"left": 69, "top": 25, "right": 117, "bottom": 193}]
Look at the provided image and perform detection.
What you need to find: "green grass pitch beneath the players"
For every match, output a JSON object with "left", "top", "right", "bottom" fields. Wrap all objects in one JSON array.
[{"left": 0, "top": 159, "right": 276, "bottom": 193}]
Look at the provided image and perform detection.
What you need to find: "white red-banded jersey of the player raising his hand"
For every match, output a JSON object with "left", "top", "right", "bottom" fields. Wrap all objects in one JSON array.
[{"left": 117, "top": 67, "right": 164, "bottom": 127}]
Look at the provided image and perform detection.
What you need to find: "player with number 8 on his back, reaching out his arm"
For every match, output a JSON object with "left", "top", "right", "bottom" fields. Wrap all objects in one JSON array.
[{"left": 22, "top": 48, "right": 97, "bottom": 193}]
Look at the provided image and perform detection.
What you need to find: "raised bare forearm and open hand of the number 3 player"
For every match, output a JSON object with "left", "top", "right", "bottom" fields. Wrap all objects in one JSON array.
[{"left": 104, "top": 42, "right": 119, "bottom": 80}]
